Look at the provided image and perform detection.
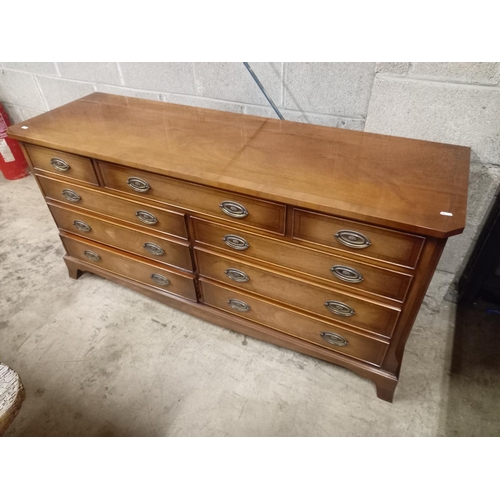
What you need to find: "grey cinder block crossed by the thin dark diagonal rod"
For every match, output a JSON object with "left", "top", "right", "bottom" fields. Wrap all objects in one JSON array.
[{"left": 194, "top": 62, "right": 282, "bottom": 107}]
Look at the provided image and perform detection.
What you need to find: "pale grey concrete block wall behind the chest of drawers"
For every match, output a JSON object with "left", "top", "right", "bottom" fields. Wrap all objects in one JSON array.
[{"left": 0, "top": 62, "right": 500, "bottom": 304}]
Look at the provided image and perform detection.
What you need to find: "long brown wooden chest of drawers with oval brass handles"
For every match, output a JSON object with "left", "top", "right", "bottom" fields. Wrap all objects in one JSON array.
[{"left": 9, "top": 93, "right": 470, "bottom": 401}]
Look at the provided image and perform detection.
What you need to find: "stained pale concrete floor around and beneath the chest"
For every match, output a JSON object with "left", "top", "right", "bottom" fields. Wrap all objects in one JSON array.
[{"left": 0, "top": 176, "right": 500, "bottom": 436}]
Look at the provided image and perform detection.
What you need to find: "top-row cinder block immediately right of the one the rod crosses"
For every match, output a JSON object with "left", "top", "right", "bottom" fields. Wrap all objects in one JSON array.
[{"left": 285, "top": 63, "right": 375, "bottom": 118}]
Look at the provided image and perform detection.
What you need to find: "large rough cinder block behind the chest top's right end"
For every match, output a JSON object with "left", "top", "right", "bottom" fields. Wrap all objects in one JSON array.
[{"left": 365, "top": 76, "right": 500, "bottom": 164}]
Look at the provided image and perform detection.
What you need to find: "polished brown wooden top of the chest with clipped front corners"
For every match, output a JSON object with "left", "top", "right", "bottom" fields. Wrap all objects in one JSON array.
[{"left": 8, "top": 93, "right": 470, "bottom": 237}]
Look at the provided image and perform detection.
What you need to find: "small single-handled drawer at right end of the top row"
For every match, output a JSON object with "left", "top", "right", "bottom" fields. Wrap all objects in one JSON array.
[{"left": 293, "top": 208, "right": 425, "bottom": 269}]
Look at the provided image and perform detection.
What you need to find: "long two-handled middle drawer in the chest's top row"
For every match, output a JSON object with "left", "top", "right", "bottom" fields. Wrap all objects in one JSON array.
[{"left": 99, "top": 162, "right": 286, "bottom": 234}]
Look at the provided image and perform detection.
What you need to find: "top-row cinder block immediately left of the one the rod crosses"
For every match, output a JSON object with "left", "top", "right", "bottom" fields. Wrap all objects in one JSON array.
[{"left": 119, "top": 62, "right": 195, "bottom": 94}]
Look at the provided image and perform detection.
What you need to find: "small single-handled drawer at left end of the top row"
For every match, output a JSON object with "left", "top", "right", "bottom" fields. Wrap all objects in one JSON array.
[{"left": 25, "top": 144, "right": 99, "bottom": 186}]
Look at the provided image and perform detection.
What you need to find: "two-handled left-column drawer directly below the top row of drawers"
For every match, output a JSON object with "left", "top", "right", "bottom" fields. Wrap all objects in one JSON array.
[{"left": 37, "top": 176, "right": 187, "bottom": 239}]
